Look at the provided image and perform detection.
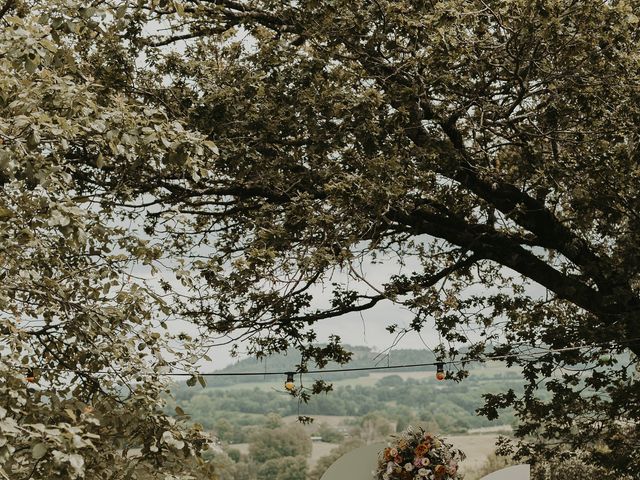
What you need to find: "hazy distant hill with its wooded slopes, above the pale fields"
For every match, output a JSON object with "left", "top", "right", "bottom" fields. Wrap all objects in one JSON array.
[{"left": 168, "top": 347, "right": 522, "bottom": 438}]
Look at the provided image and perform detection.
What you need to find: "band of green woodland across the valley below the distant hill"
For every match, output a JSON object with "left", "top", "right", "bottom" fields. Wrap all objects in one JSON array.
[{"left": 176, "top": 375, "right": 522, "bottom": 436}]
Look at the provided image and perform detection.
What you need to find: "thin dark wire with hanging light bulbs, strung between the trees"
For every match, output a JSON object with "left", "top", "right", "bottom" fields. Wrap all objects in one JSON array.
[{"left": 15, "top": 337, "right": 640, "bottom": 377}]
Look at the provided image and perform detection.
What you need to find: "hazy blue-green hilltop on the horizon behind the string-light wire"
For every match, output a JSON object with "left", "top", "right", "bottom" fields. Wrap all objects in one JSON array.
[{"left": 200, "top": 345, "right": 435, "bottom": 387}]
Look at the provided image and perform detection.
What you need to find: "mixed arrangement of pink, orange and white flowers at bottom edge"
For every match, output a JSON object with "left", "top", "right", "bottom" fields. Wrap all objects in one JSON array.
[{"left": 375, "top": 427, "right": 466, "bottom": 480}]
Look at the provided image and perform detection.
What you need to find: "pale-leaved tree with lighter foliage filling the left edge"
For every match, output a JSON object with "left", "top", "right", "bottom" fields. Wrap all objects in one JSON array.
[{"left": 0, "top": 1, "right": 216, "bottom": 480}]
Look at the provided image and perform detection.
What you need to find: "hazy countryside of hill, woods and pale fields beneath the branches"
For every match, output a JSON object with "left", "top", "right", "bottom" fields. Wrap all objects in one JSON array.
[{"left": 171, "top": 350, "right": 522, "bottom": 480}]
